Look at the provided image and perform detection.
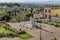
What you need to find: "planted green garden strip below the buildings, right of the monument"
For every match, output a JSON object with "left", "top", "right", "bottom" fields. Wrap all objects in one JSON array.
[{"left": 35, "top": 19, "right": 60, "bottom": 27}]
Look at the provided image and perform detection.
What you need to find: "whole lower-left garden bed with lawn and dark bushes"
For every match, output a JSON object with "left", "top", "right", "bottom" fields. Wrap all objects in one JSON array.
[{"left": 0, "top": 24, "right": 32, "bottom": 39}]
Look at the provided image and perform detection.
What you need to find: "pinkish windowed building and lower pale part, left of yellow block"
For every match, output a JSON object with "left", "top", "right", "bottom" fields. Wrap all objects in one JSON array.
[{"left": 34, "top": 7, "right": 51, "bottom": 18}]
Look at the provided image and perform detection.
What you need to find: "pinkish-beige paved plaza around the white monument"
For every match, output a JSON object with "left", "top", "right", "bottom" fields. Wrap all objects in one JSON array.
[{"left": 0, "top": 22, "right": 60, "bottom": 40}]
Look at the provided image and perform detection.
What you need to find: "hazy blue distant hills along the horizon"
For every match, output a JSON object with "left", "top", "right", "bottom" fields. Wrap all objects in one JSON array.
[{"left": 0, "top": 1, "right": 60, "bottom": 7}]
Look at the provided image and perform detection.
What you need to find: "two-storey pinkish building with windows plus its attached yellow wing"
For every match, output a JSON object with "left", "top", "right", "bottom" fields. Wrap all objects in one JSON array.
[{"left": 39, "top": 7, "right": 60, "bottom": 18}]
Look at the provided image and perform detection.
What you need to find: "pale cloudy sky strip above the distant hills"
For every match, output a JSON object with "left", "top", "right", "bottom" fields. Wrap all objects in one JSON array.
[{"left": 0, "top": 0, "right": 60, "bottom": 3}]
